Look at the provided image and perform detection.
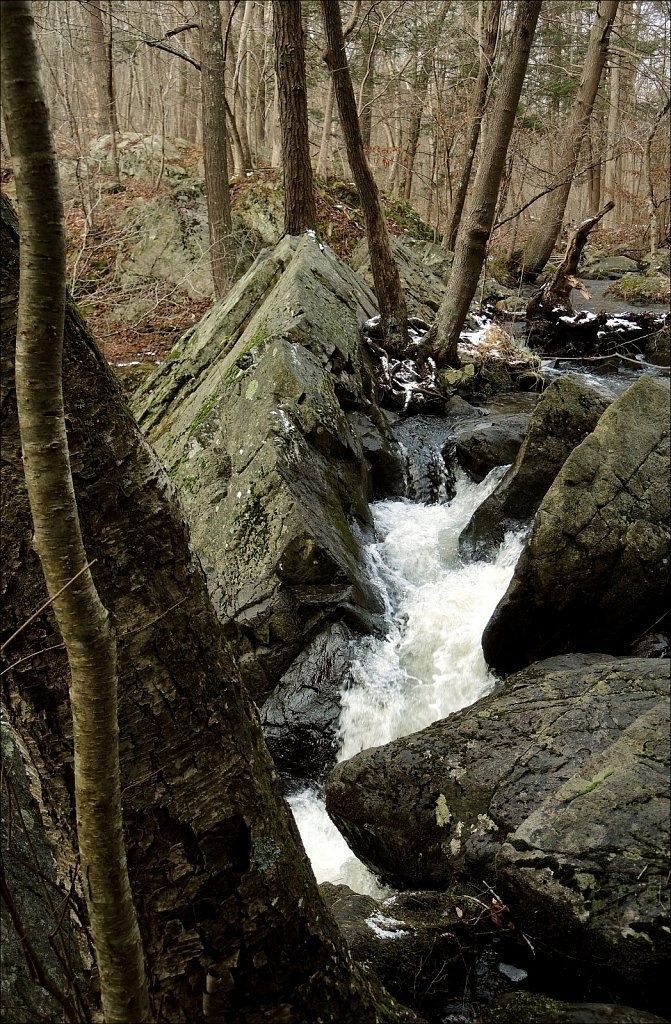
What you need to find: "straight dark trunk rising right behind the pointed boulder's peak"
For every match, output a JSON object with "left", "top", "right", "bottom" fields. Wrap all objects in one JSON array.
[{"left": 272, "top": 0, "right": 317, "bottom": 234}]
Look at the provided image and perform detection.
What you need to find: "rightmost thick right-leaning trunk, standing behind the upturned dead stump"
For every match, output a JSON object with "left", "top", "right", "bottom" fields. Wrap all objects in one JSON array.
[{"left": 525, "top": 0, "right": 619, "bottom": 281}]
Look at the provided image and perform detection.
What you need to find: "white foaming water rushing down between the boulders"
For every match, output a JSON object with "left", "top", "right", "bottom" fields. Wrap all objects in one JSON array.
[{"left": 290, "top": 468, "right": 523, "bottom": 895}]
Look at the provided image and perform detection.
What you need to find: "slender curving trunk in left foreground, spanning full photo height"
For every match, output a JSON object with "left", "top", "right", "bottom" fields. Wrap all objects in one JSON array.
[{"left": 1, "top": 0, "right": 151, "bottom": 1024}]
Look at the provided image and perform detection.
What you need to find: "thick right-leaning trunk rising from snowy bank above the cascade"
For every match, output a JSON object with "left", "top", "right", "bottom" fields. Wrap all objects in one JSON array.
[{"left": 425, "top": 0, "right": 541, "bottom": 366}]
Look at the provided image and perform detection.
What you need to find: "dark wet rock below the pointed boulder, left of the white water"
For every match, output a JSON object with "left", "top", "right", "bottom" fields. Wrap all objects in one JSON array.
[{"left": 260, "top": 623, "right": 353, "bottom": 781}]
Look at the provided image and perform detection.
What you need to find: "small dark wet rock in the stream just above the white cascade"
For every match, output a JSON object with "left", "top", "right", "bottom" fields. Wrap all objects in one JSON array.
[{"left": 455, "top": 413, "right": 529, "bottom": 483}]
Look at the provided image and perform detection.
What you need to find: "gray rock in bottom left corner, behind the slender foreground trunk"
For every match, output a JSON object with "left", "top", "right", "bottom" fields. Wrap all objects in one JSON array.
[{"left": 0, "top": 722, "right": 90, "bottom": 1024}]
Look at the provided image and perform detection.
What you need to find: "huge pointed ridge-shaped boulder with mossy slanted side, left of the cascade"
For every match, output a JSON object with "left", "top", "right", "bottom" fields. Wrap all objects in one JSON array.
[{"left": 134, "top": 232, "right": 384, "bottom": 705}]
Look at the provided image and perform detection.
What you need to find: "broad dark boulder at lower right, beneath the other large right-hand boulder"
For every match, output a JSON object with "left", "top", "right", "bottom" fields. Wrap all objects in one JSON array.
[{"left": 327, "top": 654, "right": 670, "bottom": 1007}]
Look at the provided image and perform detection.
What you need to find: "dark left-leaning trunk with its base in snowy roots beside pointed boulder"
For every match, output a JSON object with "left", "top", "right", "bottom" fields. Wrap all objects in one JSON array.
[{"left": 321, "top": 0, "right": 409, "bottom": 354}]
